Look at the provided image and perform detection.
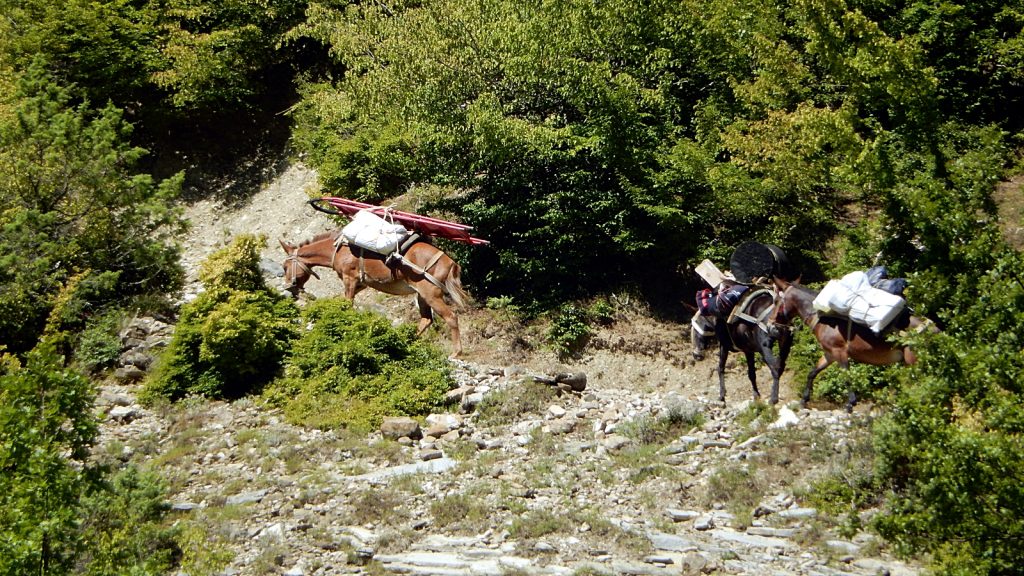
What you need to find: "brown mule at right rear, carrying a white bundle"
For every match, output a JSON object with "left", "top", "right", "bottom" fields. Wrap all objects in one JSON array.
[{"left": 773, "top": 279, "right": 934, "bottom": 412}]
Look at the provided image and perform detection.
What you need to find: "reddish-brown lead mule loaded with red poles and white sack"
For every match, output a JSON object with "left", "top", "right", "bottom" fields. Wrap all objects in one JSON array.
[{"left": 280, "top": 231, "right": 466, "bottom": 358}]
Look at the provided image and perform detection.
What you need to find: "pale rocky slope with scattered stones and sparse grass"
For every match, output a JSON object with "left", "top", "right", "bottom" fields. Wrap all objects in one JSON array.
[{"left": 98, "top": 165, "right": 918, "bottom": 576}]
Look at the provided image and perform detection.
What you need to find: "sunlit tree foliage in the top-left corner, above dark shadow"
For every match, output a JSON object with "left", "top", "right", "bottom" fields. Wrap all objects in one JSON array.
[{"left": 0, "top": 0, "right": 308, "bottom": 114}]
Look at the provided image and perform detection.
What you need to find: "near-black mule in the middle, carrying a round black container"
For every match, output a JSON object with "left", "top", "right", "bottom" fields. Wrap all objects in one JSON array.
[{"left": 715, "top": 288, "right": 793, "bottom": 404}]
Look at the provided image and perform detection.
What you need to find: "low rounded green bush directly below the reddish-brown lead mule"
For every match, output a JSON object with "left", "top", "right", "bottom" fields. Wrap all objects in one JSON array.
[{"left": 265, "top": 299, "right": 452, "bottom": 431}]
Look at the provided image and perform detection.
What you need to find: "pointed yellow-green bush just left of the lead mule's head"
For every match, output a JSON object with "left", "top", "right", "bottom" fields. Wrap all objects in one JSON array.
[{"left": 144, "top": 235, "right": 298, "bottom": 400}]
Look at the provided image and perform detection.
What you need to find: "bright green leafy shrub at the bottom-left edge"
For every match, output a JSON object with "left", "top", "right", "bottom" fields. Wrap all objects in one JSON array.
[{"left": 0, "top": 340, "right": 96, "bottom": 574}]
